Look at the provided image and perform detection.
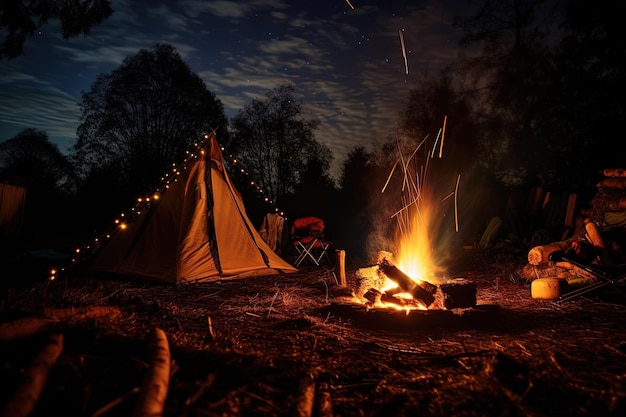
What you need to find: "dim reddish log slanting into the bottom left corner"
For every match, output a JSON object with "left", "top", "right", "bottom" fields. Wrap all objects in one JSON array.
[{"left": 2, "top": 334, "right": 63, "bottom": 417}]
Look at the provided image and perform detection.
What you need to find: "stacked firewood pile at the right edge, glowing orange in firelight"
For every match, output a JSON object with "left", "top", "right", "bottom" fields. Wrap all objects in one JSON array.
[{"left": 525, "top": 168, "right": 626, "bottom": 280}]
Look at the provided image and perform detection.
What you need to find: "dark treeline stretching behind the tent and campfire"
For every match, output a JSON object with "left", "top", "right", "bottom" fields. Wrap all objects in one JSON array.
[{"left": 0, "top": 0, "right": 626, "bottom": 260}]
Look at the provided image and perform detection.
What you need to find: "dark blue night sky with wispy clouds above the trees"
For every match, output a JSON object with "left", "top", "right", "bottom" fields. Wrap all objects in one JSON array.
[{"left": 0, "top": 0, "right": 467, "bottom": 178}]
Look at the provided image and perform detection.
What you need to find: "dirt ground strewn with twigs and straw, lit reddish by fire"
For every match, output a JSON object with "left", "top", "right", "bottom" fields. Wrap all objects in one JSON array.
[{"left": 0, "top": 250, "right": 626, "bottom": 417}]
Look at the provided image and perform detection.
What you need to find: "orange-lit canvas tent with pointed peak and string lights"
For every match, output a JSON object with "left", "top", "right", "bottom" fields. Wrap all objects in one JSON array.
[{"left": 90, "top": 135, "right": 296, "bottom": 283}]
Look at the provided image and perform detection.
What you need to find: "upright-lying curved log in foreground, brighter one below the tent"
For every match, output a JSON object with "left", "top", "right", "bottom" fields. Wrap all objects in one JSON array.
[{"left": 133, "top": 327, "right": 171, "bottom": 417}]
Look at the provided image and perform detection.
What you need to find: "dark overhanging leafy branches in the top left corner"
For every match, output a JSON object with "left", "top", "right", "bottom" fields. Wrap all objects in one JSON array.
[{"left": 0, "top": 0, "right": 113, "bottom": 59}]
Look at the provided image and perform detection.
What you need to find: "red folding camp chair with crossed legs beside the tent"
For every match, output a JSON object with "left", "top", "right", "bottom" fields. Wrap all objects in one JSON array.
[{"left": 291, "top": 216, "right": 332, "bottom": 267}]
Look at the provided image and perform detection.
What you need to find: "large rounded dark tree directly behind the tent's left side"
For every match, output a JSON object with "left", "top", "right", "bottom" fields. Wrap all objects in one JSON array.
[{"left": 73, "top": 44, "right": 228, "bottom": 203}]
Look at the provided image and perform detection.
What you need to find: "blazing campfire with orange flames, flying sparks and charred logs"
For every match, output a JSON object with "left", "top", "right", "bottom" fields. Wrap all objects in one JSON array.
[{"left": 336, "top": 129, "right": 494, "bottom": 321}]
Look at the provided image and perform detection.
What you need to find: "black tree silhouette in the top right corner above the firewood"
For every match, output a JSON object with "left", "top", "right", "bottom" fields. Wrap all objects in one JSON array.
[{"left": 540, "top": 0, "right": 626, "bottom": 193}]
